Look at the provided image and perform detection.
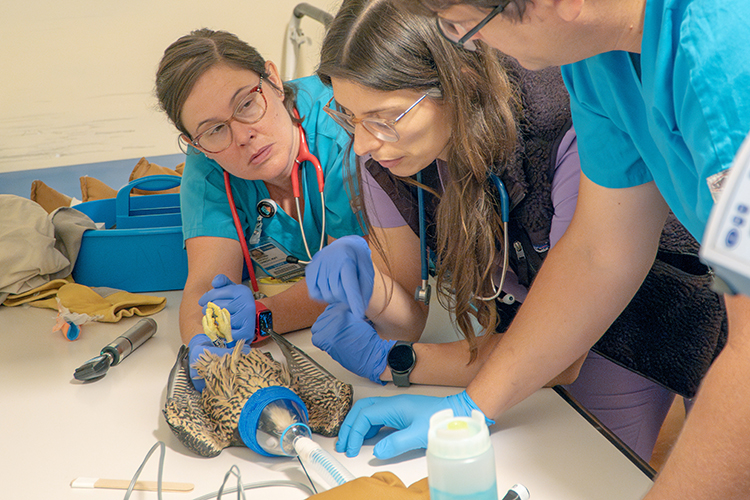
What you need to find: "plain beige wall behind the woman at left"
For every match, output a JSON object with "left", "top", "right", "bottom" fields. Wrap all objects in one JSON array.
[{"left": 0, "top": 0, "right": 339, "bottom": 173}]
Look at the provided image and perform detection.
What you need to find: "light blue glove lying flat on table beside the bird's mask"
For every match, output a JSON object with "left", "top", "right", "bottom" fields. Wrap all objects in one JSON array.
[{"left": 336, "top": 391, "right": 495, "bottom": 460}]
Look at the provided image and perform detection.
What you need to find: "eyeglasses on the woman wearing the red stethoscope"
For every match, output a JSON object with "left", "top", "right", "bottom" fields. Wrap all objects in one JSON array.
[{"left": 180, "top": 77, "right": 268, "bottom": 153}]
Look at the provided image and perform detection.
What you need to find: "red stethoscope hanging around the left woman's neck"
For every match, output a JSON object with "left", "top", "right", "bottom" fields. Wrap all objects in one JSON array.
[{"left": 224, "top": 108, "right": 326, "bottom": 294}]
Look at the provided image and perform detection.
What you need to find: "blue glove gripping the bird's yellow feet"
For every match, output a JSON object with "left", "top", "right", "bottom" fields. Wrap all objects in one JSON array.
[{"left": 198, "top": 274, "right": 255, "bottom": 347}]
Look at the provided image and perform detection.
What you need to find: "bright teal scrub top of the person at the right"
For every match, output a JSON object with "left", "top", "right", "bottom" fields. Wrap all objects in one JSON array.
[{"left": 562, "top": 0, "right": 750, "bottom": 241}]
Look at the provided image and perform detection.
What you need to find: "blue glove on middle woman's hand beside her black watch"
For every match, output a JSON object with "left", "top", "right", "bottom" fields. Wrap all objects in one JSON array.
[{"left": 311, "top": 302, "right": 396, "bottom": 385}]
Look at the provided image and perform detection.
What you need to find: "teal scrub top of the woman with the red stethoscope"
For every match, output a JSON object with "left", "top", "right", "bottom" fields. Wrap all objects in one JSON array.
[{"left": 180, "top": 76, "right": 362, "bottom": 260}]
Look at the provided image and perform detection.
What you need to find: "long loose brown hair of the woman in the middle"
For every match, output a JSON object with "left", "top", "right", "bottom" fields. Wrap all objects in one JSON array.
[{"left": 318, "top": 0, "right": 518, "bottom": 361}]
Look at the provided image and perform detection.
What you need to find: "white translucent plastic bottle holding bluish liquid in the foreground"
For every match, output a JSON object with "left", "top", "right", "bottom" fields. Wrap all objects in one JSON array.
[{"left": 427, "top": 409, "right": 498, "bottom": 500}]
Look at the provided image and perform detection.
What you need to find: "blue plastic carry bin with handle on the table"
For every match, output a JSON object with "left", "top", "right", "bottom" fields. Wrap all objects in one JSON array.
[{"left": 73, "top": 175, "right": 188, "bottom": 293}]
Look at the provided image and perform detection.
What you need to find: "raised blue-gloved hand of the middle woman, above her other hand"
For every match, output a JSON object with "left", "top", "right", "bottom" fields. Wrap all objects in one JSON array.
[{"left": 305, "top": 236, "right": 375, "bottom": 318}]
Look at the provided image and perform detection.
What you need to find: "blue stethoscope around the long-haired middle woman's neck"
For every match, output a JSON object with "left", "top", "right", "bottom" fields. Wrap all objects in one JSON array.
[{"left": 414, "top": 171, "right": 515, "bottom": 304}]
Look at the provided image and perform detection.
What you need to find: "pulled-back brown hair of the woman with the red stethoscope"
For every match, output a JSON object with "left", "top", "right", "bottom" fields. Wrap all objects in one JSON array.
[{"left": 156, "top": 28, "right": 295, "bottom": 137}]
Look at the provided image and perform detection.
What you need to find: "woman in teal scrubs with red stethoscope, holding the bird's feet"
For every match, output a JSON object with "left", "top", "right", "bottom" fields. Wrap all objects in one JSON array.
[{"left": 156, "top": 29, "right": 362, "bottom": 390}]
